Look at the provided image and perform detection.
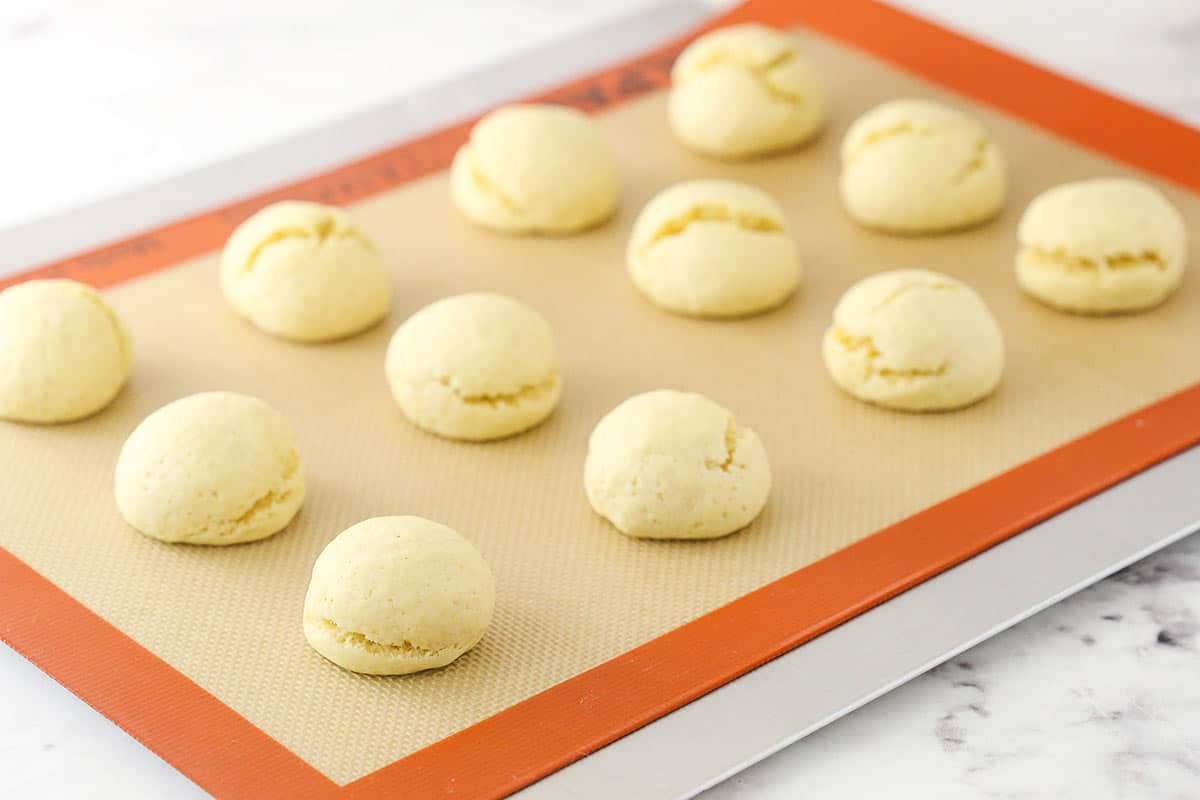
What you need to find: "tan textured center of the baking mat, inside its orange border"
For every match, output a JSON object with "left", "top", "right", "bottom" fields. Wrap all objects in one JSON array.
[{"left": 0, "top": 29, "right": 1200, "bottom": 782}]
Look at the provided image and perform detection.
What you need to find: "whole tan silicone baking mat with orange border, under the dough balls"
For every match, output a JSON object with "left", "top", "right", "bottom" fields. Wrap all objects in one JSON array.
[{"left": 0, "top": 1, "right": 1200, "bottom": 796}]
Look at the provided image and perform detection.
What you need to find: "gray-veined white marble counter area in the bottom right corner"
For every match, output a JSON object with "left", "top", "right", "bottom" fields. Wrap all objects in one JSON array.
[{"left": 703, "top": 536, "right": 1200, "bottom": 800}]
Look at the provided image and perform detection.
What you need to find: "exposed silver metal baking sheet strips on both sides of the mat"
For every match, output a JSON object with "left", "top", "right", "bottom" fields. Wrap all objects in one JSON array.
[{"left": 0, "top": 0, "right": 1200, "bottom": 800}]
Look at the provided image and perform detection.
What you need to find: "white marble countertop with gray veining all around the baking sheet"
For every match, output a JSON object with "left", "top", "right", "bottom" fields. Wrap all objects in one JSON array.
[{"left": 0, "top": 0, "right": 1200, "bottom": 800}]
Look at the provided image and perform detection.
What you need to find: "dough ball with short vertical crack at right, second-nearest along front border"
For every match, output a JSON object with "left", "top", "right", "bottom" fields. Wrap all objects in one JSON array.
[{"left": 583, "top": 390, "right": 770, "bottom": 539}]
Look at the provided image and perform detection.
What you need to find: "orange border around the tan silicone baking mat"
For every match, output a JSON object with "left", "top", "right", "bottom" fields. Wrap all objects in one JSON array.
[{"left": 0, "top": 0, "right": 1200, "bottom": 798}]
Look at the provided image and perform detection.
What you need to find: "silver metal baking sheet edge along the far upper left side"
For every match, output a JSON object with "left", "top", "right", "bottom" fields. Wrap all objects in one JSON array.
[{"left": 0, "top": 0, "right": 713, "bottom": 276}]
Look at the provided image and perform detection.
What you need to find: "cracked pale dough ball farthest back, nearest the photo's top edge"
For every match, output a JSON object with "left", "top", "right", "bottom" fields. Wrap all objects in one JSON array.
[{"left": 667, "top": 24, "right": 826, "bottom": 158}]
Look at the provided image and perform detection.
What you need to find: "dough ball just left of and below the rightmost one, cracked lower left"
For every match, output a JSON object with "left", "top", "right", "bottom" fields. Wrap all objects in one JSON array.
[{"left": 823, "top": 270, "right": 1004, "bottom": 411}]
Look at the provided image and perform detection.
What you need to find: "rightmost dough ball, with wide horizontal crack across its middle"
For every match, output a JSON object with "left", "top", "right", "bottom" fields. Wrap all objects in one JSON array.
[{"left": 1016, "top": 178, "right": 1187, "bottom": 314}]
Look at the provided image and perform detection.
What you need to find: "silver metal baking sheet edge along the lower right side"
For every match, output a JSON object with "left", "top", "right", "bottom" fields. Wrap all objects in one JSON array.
[{"left": 514, "top": 447, "right": 1200, "bottom": 800}]
